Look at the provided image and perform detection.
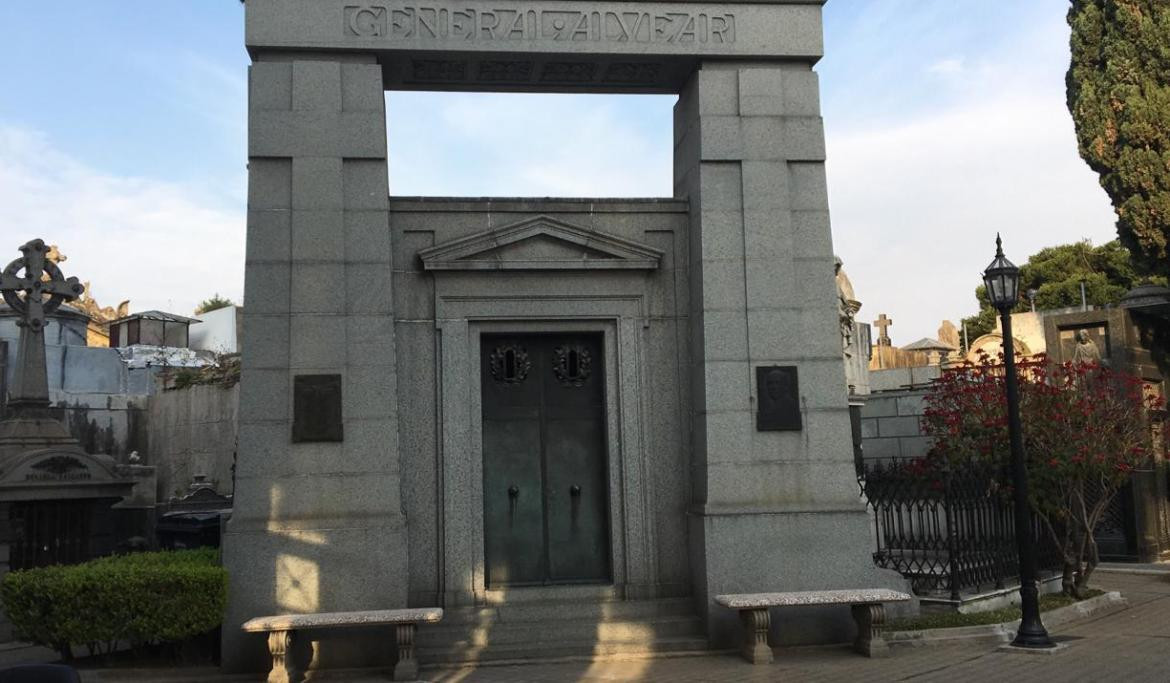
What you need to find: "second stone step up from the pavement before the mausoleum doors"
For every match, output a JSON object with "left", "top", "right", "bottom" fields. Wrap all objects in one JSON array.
[{"left": 418, "top": 616, "right": 703, "bottom": 647}]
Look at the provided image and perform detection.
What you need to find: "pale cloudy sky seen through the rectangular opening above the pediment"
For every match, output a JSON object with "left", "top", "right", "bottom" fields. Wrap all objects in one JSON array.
[{"left": 387, "top": 92, "right": 674, "bottom": 196}]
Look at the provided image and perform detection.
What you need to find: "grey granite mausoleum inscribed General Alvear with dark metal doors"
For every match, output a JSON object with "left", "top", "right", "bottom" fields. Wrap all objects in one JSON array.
[{"left": 223, "top": 0, "right": 904, "bottom": 669}]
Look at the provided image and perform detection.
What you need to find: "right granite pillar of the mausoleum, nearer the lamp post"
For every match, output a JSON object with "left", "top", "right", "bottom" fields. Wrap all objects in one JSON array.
[{"left": 675, "top": 61, "right": 904, "bottom": 646}]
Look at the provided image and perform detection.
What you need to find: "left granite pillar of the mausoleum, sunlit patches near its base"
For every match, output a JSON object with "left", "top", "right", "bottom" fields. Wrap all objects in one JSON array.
[{"left": 223, "top": 53, "right": 407, "bottom": 670}]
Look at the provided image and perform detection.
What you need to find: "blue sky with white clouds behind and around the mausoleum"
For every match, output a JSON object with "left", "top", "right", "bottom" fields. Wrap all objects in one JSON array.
[{"left": 0, "top": 0, "right": 1114, "bottom": 345}]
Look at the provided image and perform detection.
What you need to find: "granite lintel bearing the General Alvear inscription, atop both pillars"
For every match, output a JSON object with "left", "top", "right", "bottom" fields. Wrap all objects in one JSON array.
[{"left": 246, "top": 0, "right": 824, "bottom": 92}]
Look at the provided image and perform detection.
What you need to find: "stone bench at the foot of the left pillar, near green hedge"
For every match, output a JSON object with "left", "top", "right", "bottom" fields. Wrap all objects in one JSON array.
[{"left": 240, "top": 607, "right": 442, "bottom": 683}]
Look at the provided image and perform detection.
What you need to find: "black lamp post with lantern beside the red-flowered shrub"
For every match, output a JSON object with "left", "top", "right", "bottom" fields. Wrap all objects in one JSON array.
[{"left": 983, "top": 235, "right": 1055, "bottom": 648}]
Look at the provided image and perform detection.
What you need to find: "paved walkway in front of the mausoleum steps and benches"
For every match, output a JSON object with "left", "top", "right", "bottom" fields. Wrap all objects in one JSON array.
[{"left": 0, "top": 572, "right": 1170, "bottom": 683}]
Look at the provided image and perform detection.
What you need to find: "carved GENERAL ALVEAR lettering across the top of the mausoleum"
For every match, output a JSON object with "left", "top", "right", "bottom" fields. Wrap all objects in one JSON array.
[{"left": 343, "top": 2, "right": 735, "bottom": 44}]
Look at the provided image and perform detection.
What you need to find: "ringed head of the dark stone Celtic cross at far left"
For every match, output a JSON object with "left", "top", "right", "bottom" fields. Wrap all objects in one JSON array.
[{"left": 0, "top": 240, "right": 85, "bottom": 332}]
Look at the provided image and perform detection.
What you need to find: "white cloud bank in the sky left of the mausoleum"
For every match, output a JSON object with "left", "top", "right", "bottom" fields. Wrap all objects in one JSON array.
[{"left": 0, "top": 124, "right": 245, "bottom": 313}]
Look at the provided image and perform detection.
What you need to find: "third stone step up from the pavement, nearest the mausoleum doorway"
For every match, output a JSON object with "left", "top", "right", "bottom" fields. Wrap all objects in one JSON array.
[{"left": 442, "top": 598, "right": 695, "bottom": 626}]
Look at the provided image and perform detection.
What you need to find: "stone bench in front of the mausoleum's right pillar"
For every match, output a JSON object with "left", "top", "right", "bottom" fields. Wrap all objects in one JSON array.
[{"left": 715, "top": 588, "right": 910, "bottom": 664}]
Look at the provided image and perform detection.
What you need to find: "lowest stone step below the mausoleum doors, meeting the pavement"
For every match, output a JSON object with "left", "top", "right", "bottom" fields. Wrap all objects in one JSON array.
[{"left": 418, "top": 636, "right": 708, "bottom": 665}]
